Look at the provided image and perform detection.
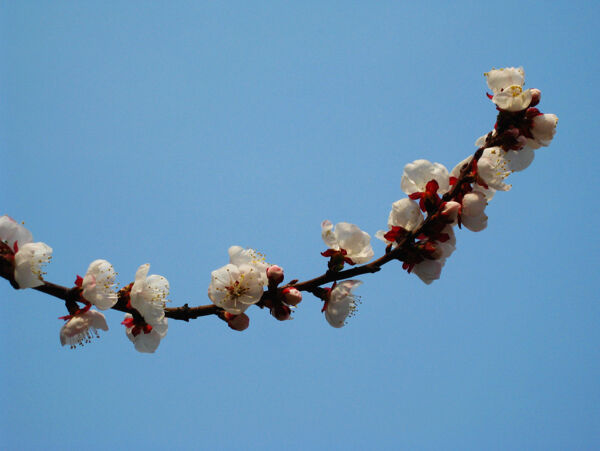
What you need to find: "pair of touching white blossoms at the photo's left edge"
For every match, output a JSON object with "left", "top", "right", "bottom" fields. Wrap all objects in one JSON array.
[{"left": 0, "top": 215, "right": 52, "bottom": 288}]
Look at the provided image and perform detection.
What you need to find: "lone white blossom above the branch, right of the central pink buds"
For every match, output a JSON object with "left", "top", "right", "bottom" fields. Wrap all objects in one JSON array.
[{"left": 321, "top": 220, "right": 375, "bottom": 265}]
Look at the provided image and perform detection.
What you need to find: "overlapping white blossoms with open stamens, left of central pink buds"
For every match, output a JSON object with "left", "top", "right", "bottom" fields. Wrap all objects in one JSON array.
[{"left": 208, "top": 246, "right": 269, "bottom": 315}]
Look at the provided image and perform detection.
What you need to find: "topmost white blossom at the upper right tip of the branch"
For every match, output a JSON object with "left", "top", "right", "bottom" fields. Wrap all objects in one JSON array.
[{"left": 484, "top": 67, "right": 532, "bottom": 111}]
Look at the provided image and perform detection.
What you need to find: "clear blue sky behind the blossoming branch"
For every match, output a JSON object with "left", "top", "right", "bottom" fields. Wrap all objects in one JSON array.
[{"left": 0, "top": 1, "right": 600, "bottom": 450}]
